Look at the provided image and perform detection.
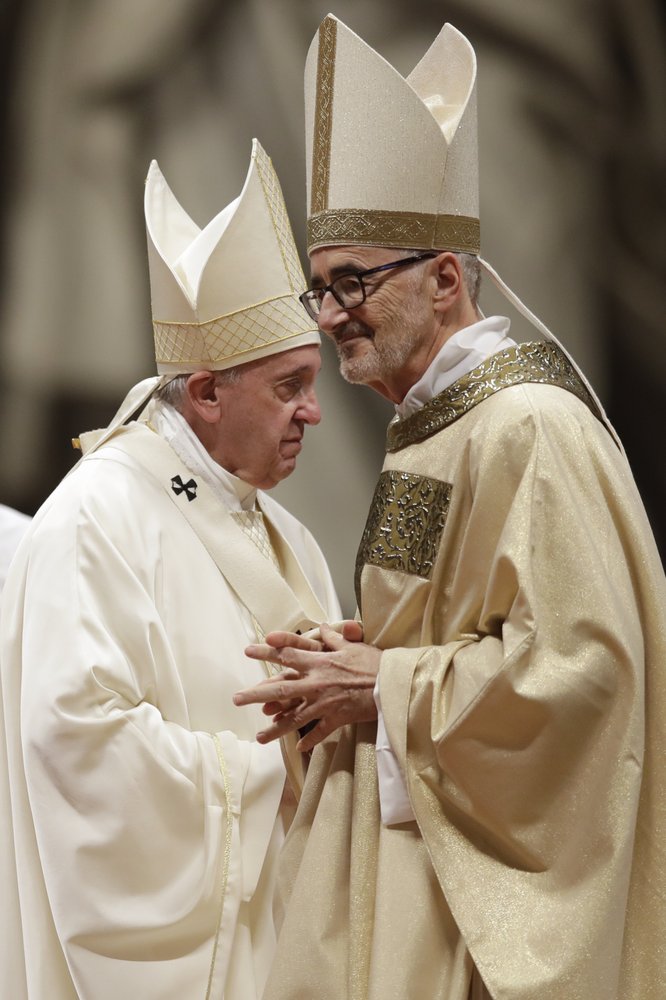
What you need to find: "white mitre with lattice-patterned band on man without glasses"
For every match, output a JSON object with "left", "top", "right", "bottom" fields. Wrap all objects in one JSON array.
[{"left": 145, "top": 139, "right": 319, "bottom": 375}]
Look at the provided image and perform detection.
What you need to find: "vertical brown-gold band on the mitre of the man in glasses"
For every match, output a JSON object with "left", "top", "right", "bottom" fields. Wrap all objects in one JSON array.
[{"left": 310, "top": 16, "right": 338, "bottom": 212}]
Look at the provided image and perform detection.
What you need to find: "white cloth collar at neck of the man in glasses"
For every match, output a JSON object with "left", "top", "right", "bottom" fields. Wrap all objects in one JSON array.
[{"left": 395, "top": 316, "right": 515, "bottom": 419}]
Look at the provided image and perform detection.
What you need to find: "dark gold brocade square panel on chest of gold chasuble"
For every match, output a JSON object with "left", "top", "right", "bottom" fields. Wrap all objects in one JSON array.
[{"left": 354, "top": 469, "right": 452, "bottom": 608}]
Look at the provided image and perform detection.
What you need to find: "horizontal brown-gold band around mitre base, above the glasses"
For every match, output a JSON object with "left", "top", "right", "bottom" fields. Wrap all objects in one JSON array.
[{"left": 307, "top": 208, "right": 481, "bottom": 254}]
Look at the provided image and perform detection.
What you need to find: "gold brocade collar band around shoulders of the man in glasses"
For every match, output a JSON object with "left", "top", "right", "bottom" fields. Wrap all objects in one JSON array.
[{"left": 386, "top": 341, "right": 601, "bottom": 452}]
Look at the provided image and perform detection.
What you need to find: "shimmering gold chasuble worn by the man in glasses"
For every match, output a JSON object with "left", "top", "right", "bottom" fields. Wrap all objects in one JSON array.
[{"left": 266, "top": 344, "right": 666, "bottom": 1000}]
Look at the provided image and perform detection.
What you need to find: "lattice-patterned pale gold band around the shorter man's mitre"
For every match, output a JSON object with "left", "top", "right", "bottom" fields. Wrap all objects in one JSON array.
[{"left": 153, "top": 294, "right": 314, "bottom": 364}]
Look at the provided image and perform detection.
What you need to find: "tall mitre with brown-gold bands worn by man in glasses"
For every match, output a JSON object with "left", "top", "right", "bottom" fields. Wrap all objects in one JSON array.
[{"left": 305, "top": 14, "right": 480, "bottom": 254}]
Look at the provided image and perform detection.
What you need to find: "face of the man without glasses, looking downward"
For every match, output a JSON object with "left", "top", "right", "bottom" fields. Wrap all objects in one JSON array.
[{"left": 211, "top": 344, "right": 321, "bottom": 489}]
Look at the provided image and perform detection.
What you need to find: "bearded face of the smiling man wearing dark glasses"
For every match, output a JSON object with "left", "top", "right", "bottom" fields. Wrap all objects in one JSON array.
[{"left": 310, "top": 246, "right": 433, "bottom": 396}]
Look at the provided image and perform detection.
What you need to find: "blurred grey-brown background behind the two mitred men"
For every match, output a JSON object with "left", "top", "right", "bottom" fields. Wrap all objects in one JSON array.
[{"left": 0, "top": 0, "right": 666, "bottom": 613}]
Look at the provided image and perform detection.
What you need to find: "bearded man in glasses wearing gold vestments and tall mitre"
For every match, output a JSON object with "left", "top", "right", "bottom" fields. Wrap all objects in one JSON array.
[{"left": 236, "top": 16, "right": 666, "bottom": 1000}]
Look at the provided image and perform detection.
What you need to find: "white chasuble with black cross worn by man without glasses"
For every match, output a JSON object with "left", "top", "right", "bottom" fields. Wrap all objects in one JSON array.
[{"left": 0, "top": 424, "right": 340, "bottom": 1000}]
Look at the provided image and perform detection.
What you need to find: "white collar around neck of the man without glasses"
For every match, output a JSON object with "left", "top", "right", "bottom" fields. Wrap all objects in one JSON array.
[{"left": 144, "top": 400, "right": 257, "bottom": 511}]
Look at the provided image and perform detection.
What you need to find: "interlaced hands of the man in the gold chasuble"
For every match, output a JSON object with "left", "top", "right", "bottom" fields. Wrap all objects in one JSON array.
[{"left": 233, "top": 621, "right": 381, "bottom": 751}]
